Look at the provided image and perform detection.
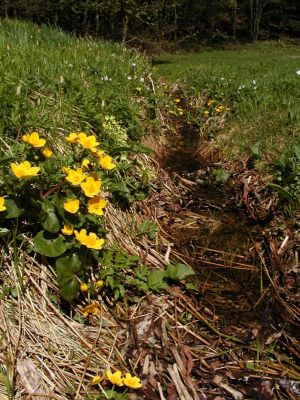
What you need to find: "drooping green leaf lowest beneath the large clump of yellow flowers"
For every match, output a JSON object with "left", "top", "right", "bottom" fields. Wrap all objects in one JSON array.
[{"left": 55, "top": 254, "right": 82, "bottom": 301}]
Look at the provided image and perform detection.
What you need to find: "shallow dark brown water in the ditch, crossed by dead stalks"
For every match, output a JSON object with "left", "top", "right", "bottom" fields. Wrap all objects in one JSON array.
[{"left": 163, "top": 123, "right": 261, "bottom": 326}]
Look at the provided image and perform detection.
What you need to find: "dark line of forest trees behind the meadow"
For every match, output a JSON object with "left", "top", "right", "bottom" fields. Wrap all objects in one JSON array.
[{"left": 0, "top": 0, "right": 300, "bottom": 42}]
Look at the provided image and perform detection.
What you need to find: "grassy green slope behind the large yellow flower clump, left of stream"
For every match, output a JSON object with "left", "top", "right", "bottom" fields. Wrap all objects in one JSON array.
[{"left": 0, "top": 20, "right": 150, "bottom": 139}]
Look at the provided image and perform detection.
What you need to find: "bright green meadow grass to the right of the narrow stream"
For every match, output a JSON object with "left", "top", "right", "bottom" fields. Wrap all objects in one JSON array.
[{"left": 153, "top": 43, "right": 300, "bottom": 166}]
